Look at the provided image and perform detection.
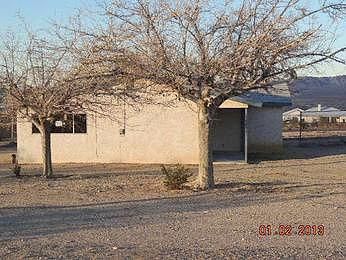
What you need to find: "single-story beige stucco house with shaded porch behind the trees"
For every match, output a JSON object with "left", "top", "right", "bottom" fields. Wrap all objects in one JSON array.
[{"left": 17, "top": 87, "right": 291, "bottom": 164}]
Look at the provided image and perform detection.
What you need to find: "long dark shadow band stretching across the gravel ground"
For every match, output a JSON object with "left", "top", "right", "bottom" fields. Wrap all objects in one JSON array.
[{"left": 0, "top": 181, "right": 346, "bottom": 241}]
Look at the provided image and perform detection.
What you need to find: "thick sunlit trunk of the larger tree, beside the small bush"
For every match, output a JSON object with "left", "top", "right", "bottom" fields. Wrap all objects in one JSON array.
[{"left": 197, "top": 102, "right": 214, "bottom": 190}]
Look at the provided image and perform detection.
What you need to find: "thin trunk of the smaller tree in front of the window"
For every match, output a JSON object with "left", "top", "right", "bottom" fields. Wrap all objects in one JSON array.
[{"left": 41, "top": 123, "right": 53, "bottom": 179}]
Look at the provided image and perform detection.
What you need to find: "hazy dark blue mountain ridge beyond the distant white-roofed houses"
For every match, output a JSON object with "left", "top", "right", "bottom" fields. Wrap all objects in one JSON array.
[{"left": 289, "top": 75, "right": 346, "bottom": 110}]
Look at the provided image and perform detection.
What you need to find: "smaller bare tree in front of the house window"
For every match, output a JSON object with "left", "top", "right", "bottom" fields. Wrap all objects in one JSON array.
[{"left": 0, "top": 29, "right": 142, "bottom": 178}]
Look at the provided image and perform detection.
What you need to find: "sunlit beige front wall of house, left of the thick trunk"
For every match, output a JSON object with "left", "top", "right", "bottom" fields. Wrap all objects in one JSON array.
[{"left": 17, "top": 100, "right": 198, "bottom": 163}]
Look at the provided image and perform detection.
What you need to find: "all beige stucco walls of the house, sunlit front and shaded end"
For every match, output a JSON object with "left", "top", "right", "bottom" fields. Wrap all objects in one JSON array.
[{"left": 17, "top": 102, "right": 282, "bottom": 164}]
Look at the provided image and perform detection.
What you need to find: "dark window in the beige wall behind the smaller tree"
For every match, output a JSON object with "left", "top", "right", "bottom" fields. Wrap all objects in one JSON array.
[{"left": 32, "top": 114, "right": 87, "bottom": 134}]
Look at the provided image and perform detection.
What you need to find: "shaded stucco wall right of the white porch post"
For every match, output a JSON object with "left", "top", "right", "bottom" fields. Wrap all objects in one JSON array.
[{"left": 248, "top": 107, "right": 283, "bottom": 153}]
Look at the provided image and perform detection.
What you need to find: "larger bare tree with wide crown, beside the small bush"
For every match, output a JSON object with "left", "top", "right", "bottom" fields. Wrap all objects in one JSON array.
[{"left": 86, "top": 0, "right": 346, "bottom": 189}]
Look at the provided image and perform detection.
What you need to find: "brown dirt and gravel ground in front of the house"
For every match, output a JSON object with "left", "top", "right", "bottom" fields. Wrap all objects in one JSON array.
[{"left": 0, "top": 145, "right": 346, "bottom": 259}]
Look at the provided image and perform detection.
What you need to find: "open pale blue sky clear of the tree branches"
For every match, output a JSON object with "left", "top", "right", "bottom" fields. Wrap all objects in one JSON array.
[{"left": 0, "top": 0, "right": 346, "bottom": 76}]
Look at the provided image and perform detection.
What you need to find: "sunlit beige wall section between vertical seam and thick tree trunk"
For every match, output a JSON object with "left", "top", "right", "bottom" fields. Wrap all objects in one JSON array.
[{"left": 97, "top": 103, "right": 198, "bottom": 163}]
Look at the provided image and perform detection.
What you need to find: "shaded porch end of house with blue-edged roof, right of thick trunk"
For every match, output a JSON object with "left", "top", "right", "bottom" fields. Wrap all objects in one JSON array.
[{"left": 213, "top": 91, "right": 291, "bottom": 163}]
